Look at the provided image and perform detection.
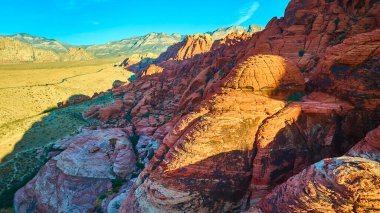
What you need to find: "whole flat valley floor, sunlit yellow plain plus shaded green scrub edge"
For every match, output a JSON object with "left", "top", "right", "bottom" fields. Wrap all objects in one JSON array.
[{"left": 0, "top": 59, "right": 131, "bottom": 208}]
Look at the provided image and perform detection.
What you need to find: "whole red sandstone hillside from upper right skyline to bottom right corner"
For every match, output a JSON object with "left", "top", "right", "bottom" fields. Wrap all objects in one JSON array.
[{"left": 15, "top": 0, "right": 380, "bottom": 212}]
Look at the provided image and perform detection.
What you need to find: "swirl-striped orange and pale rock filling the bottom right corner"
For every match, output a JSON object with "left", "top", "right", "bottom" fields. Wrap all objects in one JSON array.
[{"left": 250, "top": 127, "right": 380, "bottom": 212}]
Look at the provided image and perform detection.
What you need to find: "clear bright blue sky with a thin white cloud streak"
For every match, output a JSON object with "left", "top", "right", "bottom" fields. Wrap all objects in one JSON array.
[{"left": 0, "top": 0, "right": 289, "bottom": 45}]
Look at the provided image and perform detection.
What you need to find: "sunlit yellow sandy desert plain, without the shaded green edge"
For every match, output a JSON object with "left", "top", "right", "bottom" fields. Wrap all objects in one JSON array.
[{"left": 0, "top": 61, "right": 132, "bottom": 162}]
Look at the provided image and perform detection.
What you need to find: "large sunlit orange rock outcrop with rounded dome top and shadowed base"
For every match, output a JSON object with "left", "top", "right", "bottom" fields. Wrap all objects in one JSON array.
[{"left": 119, "top": 55, "right": 304, "bottom": 212}]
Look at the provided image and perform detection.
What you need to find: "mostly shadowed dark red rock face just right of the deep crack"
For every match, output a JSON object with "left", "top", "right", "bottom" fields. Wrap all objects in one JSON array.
[{"left": 250, "top": 92, "right": 376, "bottom": 205}]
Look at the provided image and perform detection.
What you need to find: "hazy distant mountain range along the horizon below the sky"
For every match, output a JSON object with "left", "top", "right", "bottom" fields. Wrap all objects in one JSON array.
[{"left": 0, "top": 25, "right": 262, "bottom": 64}]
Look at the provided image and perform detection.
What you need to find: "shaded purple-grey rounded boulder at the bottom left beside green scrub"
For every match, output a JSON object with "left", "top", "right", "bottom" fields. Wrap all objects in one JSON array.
[{"left": 15, "top": 129, "right": 136, "bottom": 212}]
